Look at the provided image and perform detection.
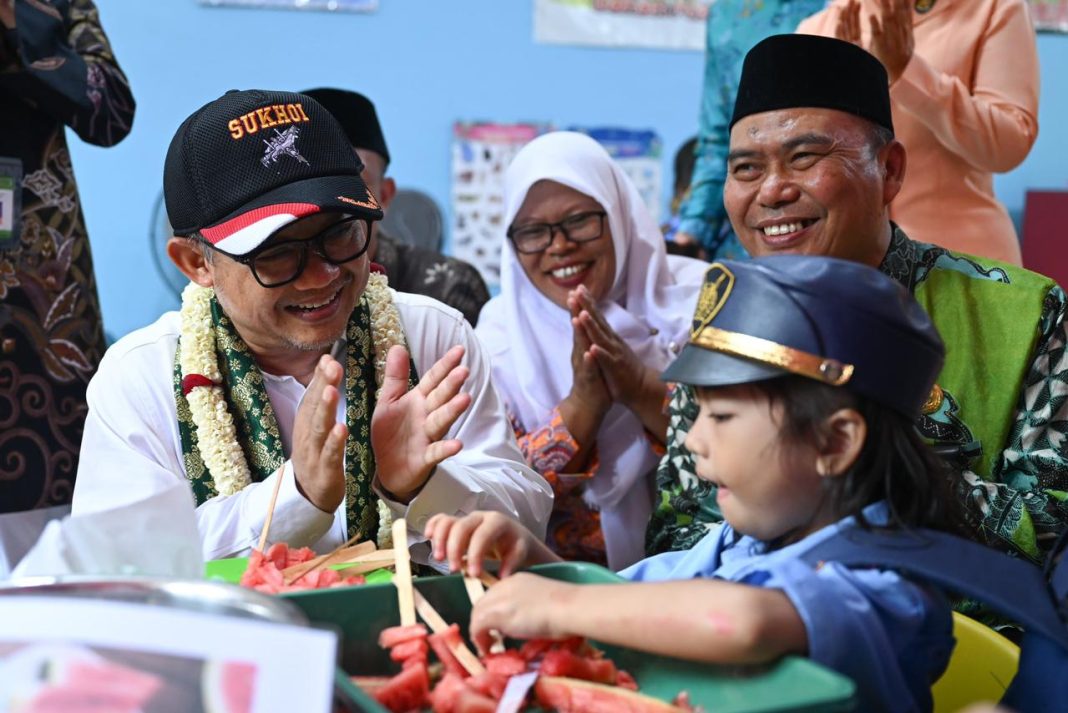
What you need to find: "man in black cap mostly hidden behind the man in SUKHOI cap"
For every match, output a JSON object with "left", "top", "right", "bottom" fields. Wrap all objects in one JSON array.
[{"left": 303, "top": 89, "right": 489, "bottom": 326}]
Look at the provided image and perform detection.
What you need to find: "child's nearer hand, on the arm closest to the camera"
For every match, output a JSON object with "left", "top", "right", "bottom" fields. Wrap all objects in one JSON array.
[{"left": 470, "top": 572, "right": 577, "bottom": 653}]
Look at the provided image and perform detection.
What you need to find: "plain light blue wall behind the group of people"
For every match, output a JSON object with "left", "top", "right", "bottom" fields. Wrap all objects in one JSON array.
[{"left": 70, "top": 0, "right": 1068, "bottom": 336}]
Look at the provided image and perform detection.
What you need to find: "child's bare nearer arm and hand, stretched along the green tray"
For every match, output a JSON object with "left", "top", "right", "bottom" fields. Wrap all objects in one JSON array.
[{"left": 471, "top": 573, "right": 808, "bottom": 663}]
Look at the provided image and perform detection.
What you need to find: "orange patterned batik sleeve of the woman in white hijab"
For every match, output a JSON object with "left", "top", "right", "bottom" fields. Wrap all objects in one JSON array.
[{"left": 509, "top": 408, "right": 608, "bottom": 565}]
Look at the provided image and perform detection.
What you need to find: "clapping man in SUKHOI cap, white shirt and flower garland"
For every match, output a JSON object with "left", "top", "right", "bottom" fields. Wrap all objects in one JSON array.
[{"left": 74, "top": 91, "right": 551, "bottom": 559}]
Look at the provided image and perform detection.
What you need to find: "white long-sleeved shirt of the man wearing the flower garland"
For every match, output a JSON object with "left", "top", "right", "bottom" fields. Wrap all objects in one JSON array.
[{"left": 73, "top": 291, "right": 552, "bottom": 563}]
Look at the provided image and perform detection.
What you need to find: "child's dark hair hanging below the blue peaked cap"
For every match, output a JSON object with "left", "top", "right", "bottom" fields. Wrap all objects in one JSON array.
[{"left": 750, "top": 376, "right": 963, "bottom": 533}]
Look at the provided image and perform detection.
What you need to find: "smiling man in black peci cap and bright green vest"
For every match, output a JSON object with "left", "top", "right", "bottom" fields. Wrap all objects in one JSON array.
[{"left": 646, "top": 35, "right": 1068, "bottom": 572}]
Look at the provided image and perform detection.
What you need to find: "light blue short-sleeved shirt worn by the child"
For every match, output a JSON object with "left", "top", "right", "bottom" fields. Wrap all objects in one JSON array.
[{"left": 619, "top": 503, "right": 954, "bottom": 712}]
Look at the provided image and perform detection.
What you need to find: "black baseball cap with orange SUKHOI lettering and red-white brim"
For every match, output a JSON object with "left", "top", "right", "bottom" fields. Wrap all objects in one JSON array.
[{"left": 163, "top": 90, "right": 382, "bottom": 255}]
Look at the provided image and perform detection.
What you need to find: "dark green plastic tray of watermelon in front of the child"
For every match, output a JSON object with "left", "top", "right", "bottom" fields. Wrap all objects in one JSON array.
[{"left": 282, "top": 563, "right": 854, "bottom": 713}]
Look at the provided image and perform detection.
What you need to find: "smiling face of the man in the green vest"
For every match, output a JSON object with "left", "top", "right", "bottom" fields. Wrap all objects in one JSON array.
[{"left": 723, "top": 108, "right": 905, "bottom": 267}]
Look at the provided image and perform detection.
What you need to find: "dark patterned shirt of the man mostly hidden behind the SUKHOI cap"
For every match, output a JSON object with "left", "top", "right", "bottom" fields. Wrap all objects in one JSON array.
[{"left": 375, "top": 228, "right": 489, "bottom": 327}]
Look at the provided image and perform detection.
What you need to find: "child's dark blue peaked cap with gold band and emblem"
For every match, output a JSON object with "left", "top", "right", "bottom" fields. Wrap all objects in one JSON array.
[{"left": 663, "top": 255, "right": 945, "bottom": 417}]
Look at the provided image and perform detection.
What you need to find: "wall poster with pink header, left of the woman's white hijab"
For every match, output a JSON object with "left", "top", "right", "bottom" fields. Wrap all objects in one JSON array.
[{"left": 451, "top": 122, "right": 549, "bottom": 290}]
